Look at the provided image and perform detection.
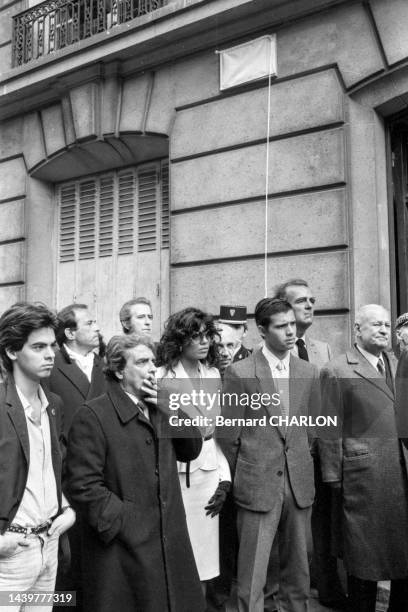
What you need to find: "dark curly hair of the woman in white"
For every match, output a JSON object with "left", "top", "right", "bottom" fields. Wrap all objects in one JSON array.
[{"left": 156, "top": 307, "right": 220, "bottom": 370}]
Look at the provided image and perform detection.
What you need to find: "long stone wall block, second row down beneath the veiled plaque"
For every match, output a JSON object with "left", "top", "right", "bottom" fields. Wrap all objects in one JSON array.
[{"left": 171, "top": 129, "right": 345, "bottom": 209}]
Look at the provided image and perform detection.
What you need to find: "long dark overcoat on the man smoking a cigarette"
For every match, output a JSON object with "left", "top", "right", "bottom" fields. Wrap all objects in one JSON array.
[{"left": 67, "top": 382, "right": 204, "bottom": 612}]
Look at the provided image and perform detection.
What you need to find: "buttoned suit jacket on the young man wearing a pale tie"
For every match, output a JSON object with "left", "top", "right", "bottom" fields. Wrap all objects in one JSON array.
[{"left": 217, "top": 350, "right": 319, "bottom": 512}]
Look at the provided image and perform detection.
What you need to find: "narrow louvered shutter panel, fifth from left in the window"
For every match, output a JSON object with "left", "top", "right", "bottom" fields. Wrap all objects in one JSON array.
[{"left": 138, "top": 167, "right": 157, "bottom": 251}]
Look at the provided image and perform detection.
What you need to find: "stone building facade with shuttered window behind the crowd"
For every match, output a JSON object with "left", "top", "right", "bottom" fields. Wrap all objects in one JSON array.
[{"left": 0, "top": 0, "right": 408, "bottom": 350}]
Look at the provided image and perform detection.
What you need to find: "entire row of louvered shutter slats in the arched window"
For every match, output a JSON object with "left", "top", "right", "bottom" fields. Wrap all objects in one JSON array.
[{"left": 59, "top": 162, "right": 169, "bottom": 263}]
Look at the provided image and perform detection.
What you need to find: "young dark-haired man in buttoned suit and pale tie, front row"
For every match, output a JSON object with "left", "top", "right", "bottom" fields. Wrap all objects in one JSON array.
[{"left": 219, "top": 298, "right": 319, "bottom": 612}]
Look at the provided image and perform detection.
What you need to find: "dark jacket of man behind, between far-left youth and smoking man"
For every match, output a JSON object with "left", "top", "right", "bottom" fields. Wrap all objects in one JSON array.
[{"left": 46, "top": 347, "right": 106, "bottom": 435}]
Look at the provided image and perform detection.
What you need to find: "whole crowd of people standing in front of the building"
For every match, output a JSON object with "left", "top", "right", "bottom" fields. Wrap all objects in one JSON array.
[{"left": 0, "top": 279, "right": 408, "bottom": 612}]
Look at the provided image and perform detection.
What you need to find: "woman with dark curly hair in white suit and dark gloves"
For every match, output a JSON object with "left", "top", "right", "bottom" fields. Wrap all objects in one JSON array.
[{"left": 157, "top": 308, "right": 231, "bottom": 591}]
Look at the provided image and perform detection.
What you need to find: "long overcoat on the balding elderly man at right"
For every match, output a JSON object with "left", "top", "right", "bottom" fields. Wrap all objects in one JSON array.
[{"left": 319, "top": 348, "right": 408, "bottom": 581}]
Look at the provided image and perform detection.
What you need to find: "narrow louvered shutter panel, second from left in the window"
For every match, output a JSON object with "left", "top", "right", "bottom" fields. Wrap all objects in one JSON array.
[{"left": 79, "top": 180, "right": 96, "bottom": 259}]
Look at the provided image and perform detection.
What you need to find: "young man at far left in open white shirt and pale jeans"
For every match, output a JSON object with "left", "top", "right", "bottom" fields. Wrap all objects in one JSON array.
[{"left": 0, "top": 302, "right": 75, "bottom": 612}]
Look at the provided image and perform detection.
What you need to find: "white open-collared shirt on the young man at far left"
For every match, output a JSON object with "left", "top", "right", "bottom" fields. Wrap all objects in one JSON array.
[{"left": 13, "top": 387, "right": 58, "bottom": 527}]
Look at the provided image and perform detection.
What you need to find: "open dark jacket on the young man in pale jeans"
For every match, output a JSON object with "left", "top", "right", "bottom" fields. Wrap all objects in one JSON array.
[{"left": 0, "top": 376, "right": 62, "bottom": 534}]
